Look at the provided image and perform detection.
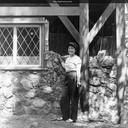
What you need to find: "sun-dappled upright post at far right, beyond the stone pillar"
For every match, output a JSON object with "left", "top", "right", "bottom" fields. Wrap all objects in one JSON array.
[{"left": 116, "top": 3, "right": 126, "bottom": 124}]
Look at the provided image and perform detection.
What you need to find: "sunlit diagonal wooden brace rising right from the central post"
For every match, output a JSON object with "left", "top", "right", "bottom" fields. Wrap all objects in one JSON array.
[{"left": 87, "top": 1, "right": 115, "bottom": 43}]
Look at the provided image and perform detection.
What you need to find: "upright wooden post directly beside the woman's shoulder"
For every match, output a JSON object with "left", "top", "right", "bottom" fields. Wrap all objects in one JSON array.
[{"left": 80, "top": 2, "right": 89, "bottom": 112}]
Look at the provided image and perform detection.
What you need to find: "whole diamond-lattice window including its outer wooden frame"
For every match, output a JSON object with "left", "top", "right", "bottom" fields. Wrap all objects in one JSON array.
[{"left": 0, "top": 17, "right": 49, "bottom": 70}]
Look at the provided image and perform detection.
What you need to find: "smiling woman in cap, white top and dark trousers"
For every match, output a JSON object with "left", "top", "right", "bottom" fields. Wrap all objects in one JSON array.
[{"left": 59, "top": 42, "right": 81, "bottom": 122}]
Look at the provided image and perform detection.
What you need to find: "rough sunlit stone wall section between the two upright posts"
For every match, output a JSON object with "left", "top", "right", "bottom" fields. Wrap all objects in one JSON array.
[{"left": 89, "top": 51, "right": 119, "bottom": 123}]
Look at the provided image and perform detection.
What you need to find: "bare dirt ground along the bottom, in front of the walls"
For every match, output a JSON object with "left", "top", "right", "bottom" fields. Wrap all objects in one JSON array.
[{"left": 0, "top": 115, "right": 128, "bottom": 128}]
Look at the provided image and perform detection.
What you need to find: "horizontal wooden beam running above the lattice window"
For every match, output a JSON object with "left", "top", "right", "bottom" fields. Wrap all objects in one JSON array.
[{"left": 0, "top": 6, "right": 79, "bottom": 16}]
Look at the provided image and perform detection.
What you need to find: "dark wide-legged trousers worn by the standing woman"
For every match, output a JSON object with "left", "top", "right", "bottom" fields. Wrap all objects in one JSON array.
[{"left": 60, "top": 72, "right": 79, "bottom": 121}]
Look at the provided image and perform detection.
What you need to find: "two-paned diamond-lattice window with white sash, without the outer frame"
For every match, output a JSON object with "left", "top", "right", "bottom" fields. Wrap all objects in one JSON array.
[{"left": 0, "top": 25, "right": 43, "bottom": 67}]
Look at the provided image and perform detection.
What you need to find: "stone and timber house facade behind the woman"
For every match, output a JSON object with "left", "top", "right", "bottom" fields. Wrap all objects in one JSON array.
[{"left": 0, "top": 0, "right": 127, "bottom": 123}]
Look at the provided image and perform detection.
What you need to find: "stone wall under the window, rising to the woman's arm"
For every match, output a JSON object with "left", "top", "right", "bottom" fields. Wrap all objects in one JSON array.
[{"left": 0, "top": 51, "right": 65, "bottom": 116}]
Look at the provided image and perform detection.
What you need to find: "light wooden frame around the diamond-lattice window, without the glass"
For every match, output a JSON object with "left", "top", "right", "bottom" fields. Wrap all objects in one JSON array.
[{"left": 0, "top": 17, "right": 49, "bottom": 70}]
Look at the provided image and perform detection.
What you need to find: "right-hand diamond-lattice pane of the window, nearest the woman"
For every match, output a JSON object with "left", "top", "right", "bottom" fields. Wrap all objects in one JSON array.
[{"left": 17, "top": 27, "right": 40, "bottom": 65}]
